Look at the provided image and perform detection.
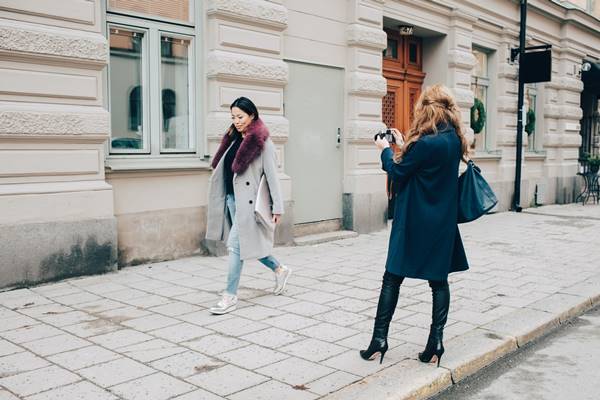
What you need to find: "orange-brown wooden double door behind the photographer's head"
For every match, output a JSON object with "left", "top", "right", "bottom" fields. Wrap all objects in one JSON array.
[{"left": 382, "top": 30, "right": 425, "bottom": 133}]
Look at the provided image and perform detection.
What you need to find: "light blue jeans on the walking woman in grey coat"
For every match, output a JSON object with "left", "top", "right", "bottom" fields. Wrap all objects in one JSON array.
[{"left": 225, "top": 194, "right": 280, "bottom": 295}]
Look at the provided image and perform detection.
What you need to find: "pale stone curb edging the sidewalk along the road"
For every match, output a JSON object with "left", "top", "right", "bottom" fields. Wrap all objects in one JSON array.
[{"left": 322, "top": 274, "right": 600, "bottom": 400}]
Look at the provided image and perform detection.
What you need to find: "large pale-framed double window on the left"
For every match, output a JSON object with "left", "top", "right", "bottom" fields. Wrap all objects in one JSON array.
[{"left": 107, "top": 0, "right": 198, "bottom": 156}]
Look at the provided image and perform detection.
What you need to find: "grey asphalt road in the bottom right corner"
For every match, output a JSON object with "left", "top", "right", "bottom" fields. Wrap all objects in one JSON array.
[{"left": 432, "top": 307, "right": 600, "bottom": 400}]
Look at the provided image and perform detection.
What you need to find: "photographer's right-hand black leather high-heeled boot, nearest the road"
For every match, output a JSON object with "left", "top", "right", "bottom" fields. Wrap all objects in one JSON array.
[{"left": 419, "top": 281, "right": 450, "bottom": 367}]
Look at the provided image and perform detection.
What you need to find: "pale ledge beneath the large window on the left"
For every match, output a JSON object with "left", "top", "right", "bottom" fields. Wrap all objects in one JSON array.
[{"left": 105, "top": 156, "right": 211, "bottom": 173}]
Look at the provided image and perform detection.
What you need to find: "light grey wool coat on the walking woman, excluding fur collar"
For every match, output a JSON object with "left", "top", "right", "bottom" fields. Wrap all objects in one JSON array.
[{"left": 206, "top": 138, "right": 283, "bottom": 260}]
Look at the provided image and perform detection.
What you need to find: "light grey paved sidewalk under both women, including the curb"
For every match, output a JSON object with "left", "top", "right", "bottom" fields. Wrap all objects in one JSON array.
[{"left": 0, "top": 205, "right": 600, "bottom": 400}]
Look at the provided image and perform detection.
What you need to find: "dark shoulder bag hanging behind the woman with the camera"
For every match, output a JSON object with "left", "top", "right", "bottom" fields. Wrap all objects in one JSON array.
[{"left": 458, "top": 160, "right": 498, "bottom": 224}]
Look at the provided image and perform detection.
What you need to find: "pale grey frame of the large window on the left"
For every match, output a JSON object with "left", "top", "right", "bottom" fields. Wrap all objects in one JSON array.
[{"left": 101, "top": 0, "right": 208, "bottom": 163}]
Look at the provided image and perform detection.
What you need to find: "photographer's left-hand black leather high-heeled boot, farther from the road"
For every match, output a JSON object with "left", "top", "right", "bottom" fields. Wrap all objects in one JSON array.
[{"left": 360, "top": 272, "right": 404, "bottom": 364}]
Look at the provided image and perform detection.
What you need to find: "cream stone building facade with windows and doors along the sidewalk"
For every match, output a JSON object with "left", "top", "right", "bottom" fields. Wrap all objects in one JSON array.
[{"left": 0, "top": 0, "right": 600, "bottom": 287}]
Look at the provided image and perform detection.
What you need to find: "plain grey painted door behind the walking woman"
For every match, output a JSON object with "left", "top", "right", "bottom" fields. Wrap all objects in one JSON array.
[{"left": 284, "top": 62, "right": 344, "bottom": 224}]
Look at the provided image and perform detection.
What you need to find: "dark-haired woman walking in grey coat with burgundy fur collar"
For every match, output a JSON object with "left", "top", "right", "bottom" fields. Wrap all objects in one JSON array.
[{"left": 206, "top": 97, "right": 292, "bottom": 314}]
